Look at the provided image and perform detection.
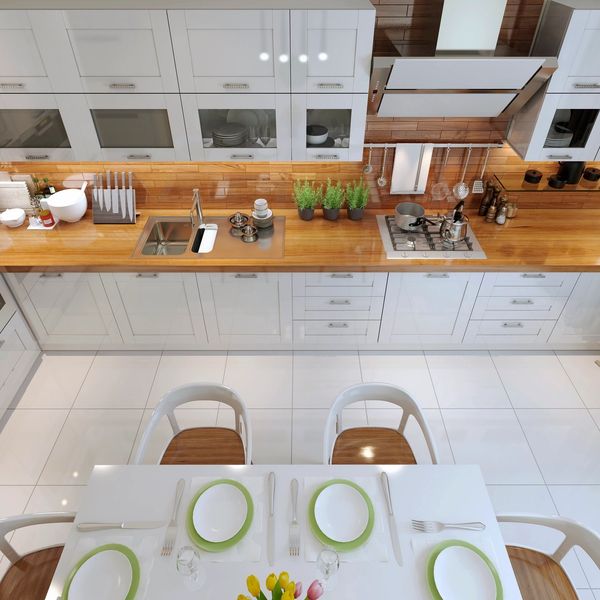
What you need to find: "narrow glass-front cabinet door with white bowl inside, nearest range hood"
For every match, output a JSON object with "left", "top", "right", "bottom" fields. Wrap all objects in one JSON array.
[{"left": 292, "top": 94, "right": 367, "bottom": 161}]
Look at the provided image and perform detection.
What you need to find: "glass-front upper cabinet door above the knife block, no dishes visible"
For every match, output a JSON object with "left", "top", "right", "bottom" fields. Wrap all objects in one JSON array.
[{"left": 78, "top": 94, "right": 190, "bottom": 161}]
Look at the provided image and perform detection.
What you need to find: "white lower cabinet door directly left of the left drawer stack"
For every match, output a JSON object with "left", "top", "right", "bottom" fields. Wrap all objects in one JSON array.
[{"left": 197, "top": 273, "right": 292, "bottom": 349}]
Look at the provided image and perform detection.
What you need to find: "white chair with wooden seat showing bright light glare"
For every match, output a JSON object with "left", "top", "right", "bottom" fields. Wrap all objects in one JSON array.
[{"left": 323, "top": 383, "right": 438, "bottom": 465}]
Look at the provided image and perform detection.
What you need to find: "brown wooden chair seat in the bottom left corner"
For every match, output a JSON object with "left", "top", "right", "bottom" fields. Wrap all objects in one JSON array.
[{"left": 0, "top": 546, "right": 63, "bottom": 600}]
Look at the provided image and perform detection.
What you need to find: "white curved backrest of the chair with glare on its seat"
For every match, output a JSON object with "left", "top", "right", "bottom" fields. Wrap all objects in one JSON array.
[{"left": 323, "top": 383, "right": 438, "bottom": 465}]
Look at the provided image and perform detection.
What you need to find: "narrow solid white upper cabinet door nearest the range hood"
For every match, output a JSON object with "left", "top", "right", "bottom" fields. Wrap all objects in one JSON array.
[{"left": 291, "top": 10, "right": 375, "bottom": 93}]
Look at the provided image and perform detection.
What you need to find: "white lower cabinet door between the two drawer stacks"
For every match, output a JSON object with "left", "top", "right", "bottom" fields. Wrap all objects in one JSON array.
[{"left": 379, "top": 273, "right": 482, "bottom": 348}]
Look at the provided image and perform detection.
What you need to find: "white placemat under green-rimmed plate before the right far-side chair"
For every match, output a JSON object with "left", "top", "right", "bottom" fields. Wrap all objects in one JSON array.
[{"left": 300, "top": 477, "right": 389, "bottom": 562}]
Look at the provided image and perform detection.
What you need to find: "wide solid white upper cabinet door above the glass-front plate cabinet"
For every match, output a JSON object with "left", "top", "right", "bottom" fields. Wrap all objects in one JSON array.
[{"left": 168, "top": 10, "right": 290, "bottom": 94}]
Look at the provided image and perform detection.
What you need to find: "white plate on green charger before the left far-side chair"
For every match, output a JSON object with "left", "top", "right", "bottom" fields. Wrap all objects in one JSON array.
[{"left": 193, "top": 483, "right": 248, "bottom": 543}]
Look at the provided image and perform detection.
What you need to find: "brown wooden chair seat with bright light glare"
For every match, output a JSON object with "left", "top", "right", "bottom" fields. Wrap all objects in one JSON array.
[{"left": 331, "top": 427, "right": 417, "bottom": 465}]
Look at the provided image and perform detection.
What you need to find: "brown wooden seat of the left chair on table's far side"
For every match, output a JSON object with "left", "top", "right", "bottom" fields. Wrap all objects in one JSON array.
[{"left": 160, "top": 427, "right": 246, "bottom": 465}]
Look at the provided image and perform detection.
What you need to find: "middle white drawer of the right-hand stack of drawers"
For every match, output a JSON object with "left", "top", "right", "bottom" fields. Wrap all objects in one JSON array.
[{"left": 471, "top": 296, "right": 568, "bottom": 320}]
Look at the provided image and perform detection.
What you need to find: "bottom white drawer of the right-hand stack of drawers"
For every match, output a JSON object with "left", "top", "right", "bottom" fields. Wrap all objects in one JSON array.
[{"left": 463, "top": 319, "right": 556, "bottom": 348}]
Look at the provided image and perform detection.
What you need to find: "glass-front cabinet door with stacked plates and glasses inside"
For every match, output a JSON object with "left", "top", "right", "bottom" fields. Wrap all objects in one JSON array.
[{"left": 182, "top": 94, "right": 291, "bottom": 161}]
